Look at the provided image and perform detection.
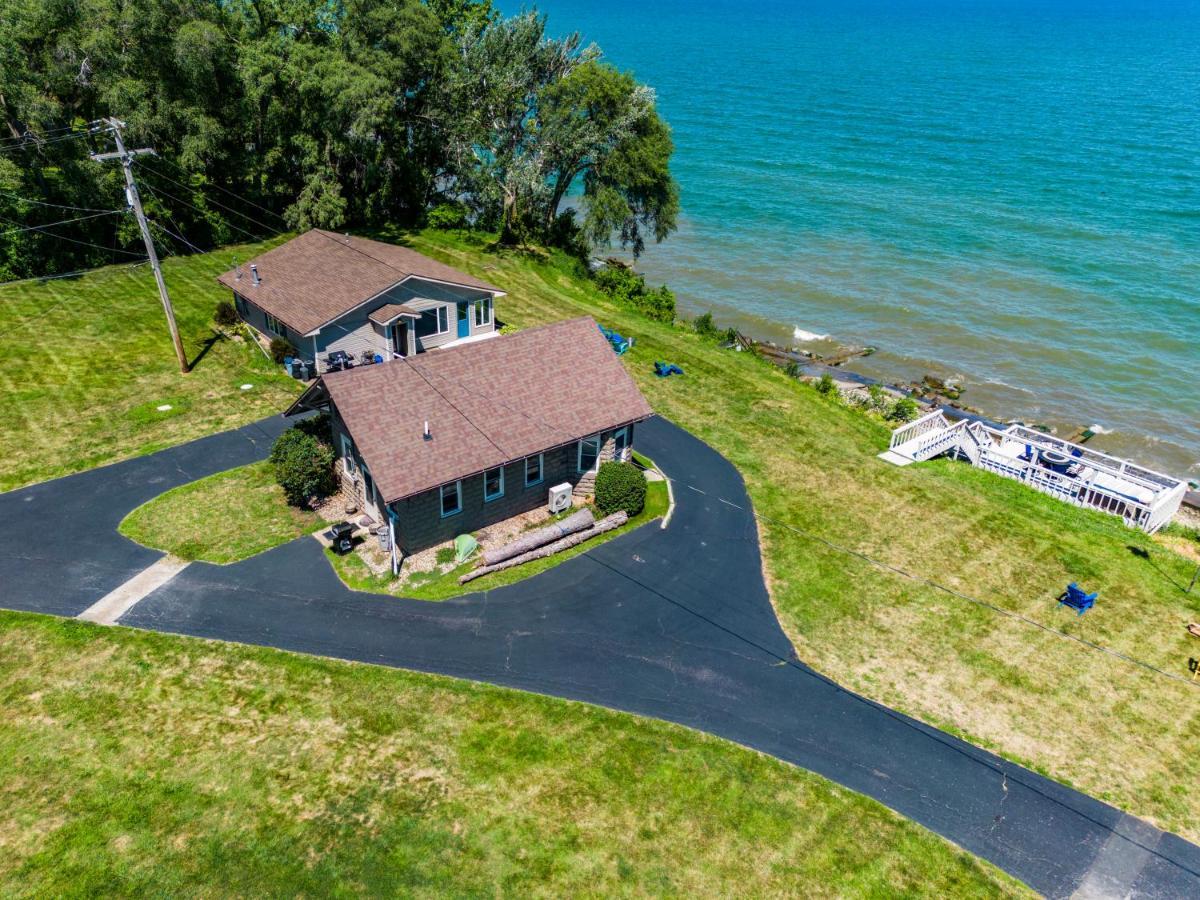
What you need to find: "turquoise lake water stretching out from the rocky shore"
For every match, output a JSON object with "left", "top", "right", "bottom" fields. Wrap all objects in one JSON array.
[{"left": 518, "top": 0, "right": 1200, "bottom": 478}]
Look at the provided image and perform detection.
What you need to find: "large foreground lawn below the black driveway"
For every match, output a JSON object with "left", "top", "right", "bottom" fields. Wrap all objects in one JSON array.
[{"left": 0, "top": 613, "right": 1024, "bottom": 896}]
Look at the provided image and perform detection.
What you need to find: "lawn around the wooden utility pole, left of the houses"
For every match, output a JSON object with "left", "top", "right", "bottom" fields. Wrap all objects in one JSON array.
[{"left": 0, "top": 240, "right": 298, "bottom": 491}]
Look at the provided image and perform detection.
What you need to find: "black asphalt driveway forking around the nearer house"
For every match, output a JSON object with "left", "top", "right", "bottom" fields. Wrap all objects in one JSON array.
[{"left": 0, "top": 420, "right": 1200, "bottom": 896}]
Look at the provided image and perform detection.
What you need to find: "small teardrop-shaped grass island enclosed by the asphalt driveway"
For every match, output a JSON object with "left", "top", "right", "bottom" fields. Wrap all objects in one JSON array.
[{"left": 120, "top": 461, "right": 323, "bottom": 563}]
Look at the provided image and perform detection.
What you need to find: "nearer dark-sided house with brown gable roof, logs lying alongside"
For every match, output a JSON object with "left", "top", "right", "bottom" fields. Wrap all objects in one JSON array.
[{"left": 287, "top": 317, "right": 653, "bottom": 559}]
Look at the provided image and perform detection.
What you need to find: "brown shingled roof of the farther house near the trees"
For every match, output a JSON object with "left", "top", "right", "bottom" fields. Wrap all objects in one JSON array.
[{"left": 217, "top": 229, "right": 504, "bottom": 335}]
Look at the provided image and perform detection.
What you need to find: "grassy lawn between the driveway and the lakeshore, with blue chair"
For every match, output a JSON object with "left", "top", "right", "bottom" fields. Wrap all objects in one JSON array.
[{"left": 398, "top": 232, "right": 1200, "bottom": 839}]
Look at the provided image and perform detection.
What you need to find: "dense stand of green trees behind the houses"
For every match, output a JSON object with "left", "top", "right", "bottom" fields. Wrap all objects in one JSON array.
[{"left": 0, "top": 0, "right": 678, "bottom": 280}]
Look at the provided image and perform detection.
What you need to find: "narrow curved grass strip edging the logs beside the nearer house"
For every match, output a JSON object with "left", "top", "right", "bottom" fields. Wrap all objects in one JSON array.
[{"left": 325, "top": 482, "right": 668, "bottom": 600}]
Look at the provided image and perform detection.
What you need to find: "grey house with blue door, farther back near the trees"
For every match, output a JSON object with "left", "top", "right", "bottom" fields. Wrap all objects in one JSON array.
[{"left": 217, "top": 234, "right": 504, "bottom": 372}]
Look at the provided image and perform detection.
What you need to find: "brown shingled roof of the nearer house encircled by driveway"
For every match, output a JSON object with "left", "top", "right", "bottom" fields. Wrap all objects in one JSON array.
[{"left": 310, "top": 317, "right": 653, "bottom": 503}]
